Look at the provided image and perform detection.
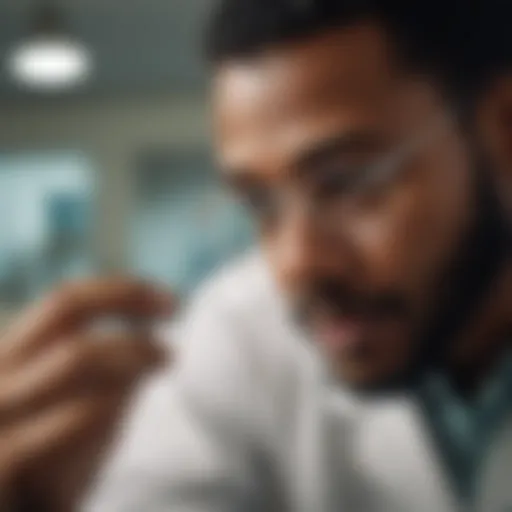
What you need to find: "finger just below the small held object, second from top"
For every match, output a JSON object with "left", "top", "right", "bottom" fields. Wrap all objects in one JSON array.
[{"left": 0, "top": 336, "right": 170, "bottom": 425}]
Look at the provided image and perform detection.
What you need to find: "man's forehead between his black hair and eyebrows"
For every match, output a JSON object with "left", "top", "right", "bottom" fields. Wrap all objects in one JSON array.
[{"left": 213, "top": 23, "right": 440, "bottom": 178}]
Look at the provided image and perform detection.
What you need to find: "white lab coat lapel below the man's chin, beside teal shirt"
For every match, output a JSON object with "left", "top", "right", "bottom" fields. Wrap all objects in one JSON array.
[{"left": 355, "top": 398, "right": 458, "bottom": 512}]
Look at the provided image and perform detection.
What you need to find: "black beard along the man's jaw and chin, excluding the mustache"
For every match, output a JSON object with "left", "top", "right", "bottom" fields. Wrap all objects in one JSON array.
[{"left": 370, "top": 165, "right": 512, "bottom": 394}]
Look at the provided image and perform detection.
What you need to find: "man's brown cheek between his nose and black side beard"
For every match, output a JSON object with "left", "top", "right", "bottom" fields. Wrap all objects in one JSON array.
[{"left": 349, "top": 151, "right": 469, "bottom": 296}]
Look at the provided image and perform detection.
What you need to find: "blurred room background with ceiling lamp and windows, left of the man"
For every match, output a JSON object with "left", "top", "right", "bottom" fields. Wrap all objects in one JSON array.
[{"left": 0, "top": 0, "right": 252, "bottom": 325}]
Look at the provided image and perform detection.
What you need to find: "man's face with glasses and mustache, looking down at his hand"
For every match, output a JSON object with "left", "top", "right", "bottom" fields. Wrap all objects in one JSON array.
[{"left": 214, "top": 23, "right": 473, "bottom": 388}]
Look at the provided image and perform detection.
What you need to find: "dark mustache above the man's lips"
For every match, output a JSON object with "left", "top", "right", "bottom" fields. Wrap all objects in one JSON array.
[{"left": 294, "top": 280, "right": 410, "bottom": 321}]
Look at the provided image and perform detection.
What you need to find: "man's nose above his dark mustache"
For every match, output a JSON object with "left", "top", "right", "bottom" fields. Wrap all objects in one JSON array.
[{"left": 272, "top": 198, "right": 351, "bottom": 289}]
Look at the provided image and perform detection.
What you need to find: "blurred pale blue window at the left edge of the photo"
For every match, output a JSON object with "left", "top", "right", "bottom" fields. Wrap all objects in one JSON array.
[{"left": 0, "top": 152, "right": 94, "bottom": 306}]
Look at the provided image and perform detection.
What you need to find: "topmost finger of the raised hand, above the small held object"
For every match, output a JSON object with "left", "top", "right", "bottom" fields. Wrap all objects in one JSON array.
[{"left": 2, "top": 278, "right": 174, "bottom": 353}]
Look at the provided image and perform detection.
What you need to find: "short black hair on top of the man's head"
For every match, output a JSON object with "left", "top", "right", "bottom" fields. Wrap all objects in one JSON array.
[{"left": 206, "top": 0, "right": 485, "bottom": 101}]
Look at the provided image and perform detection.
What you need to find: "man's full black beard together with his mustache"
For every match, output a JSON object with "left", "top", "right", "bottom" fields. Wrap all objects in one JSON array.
[{"left": 295, "top": 160, "right": 512, "bottom": 396}]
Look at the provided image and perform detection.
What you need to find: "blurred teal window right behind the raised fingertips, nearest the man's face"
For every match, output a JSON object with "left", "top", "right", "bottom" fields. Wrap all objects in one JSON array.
[{"left": 130, "top": 155, "right": 252, "bottom": 294}]
